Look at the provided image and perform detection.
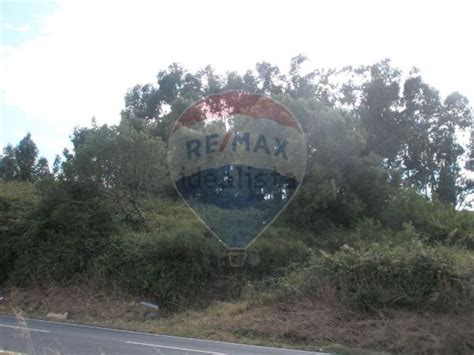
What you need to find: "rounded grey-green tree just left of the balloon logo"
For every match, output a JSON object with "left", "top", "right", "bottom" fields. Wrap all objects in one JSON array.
[{"left": 61, "top": 119, "right": 170, "bottom": 224}]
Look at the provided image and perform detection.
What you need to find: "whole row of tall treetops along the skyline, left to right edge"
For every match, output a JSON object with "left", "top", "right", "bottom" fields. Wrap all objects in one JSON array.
[{"left": 0, "top": 55, "right": 474, "bottom": 207}]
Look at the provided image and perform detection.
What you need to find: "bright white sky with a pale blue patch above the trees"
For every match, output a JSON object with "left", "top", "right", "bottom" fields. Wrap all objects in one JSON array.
[{"left": 0, "top": 0, "right": 474, "bottom": 162}]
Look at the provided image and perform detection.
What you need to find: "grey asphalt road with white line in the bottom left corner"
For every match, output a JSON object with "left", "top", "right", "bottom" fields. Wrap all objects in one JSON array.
[{"left": 0, "top": 316, "right": 321, "bottom": 355}]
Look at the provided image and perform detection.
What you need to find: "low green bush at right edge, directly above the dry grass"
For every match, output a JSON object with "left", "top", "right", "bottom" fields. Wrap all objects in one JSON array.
[{"left": 301, "top": 240, "right": 474, "bottom": 309}]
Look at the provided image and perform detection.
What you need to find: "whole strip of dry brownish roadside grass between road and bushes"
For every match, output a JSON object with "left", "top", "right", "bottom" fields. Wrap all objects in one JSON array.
[{"left": 0, "top": 286, "right": 474, "bottom": 354}]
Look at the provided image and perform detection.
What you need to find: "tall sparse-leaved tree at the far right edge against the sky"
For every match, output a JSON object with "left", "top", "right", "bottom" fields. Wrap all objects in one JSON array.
[{"left": 402, "top": 75, "right": 472, "bottom": 207}]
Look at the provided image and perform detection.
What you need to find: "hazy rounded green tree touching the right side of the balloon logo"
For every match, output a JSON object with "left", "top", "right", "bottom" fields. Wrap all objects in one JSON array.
[{"left": 278, "top": 95, "right": 392, "bottom": 230}]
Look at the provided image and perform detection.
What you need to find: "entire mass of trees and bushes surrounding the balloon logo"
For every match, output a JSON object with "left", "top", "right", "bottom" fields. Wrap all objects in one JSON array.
[{"left": 0, "top": 56, "right": 474, "bottom": 312}]
